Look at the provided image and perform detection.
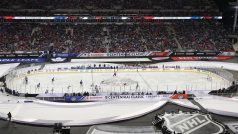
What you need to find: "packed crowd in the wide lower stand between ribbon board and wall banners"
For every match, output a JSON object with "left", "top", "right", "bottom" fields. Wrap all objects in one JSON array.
[{"left": 0, "top": 22, "right": 232, "bottom": 53}]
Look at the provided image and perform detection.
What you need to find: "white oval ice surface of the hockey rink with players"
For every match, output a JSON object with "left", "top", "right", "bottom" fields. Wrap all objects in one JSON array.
[{"left": 7, "top": 67, "right": 230, "bottom": 94}]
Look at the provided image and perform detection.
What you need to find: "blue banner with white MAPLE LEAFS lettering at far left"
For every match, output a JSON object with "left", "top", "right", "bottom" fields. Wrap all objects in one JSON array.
[{"left": 0, "top": 58, "right": 47, "bottom": 63}]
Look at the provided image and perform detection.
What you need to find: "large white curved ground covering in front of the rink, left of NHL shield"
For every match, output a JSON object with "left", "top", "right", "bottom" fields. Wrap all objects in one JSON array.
[{"left": 0, "top": 93, "right": 167, "bottom": 126}]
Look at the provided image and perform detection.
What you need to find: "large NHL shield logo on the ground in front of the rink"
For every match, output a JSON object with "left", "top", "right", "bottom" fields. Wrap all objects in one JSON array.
[{"left": 161, "top": 113, "right": 224, "bottom": 134}]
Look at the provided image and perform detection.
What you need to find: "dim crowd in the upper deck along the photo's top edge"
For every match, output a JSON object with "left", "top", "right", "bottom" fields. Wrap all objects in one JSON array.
[{"left": 0, "top": 0, "right": 218, "bottom": 9}]
